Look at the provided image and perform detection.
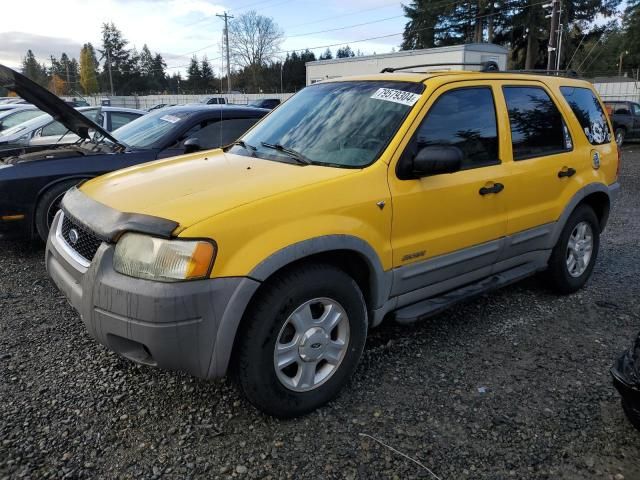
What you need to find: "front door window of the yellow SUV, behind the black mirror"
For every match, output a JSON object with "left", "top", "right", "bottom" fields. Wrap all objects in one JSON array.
[{"left": 417, "top": 87, "right": 500, "bottom": 169}]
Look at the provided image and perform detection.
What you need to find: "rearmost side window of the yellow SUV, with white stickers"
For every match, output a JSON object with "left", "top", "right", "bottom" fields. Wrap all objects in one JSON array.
[{"left": 560, "top": 87, "right": 611, "bottom": 145}]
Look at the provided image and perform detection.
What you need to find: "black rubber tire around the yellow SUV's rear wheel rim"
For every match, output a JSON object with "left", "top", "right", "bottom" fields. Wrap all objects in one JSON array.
[{"left": 545, "top": 205, "right": 600, "bottom": 295}]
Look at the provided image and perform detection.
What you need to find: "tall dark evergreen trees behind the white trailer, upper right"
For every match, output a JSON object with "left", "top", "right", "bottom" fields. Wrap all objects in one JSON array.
[{"left": 401, "top": 0, "right": 640, "bottom": 76}]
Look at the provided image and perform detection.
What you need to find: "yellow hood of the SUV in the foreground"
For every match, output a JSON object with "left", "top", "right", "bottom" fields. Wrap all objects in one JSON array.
[{"left": 80, "top": 150, "right": 358, "bottom": 233}]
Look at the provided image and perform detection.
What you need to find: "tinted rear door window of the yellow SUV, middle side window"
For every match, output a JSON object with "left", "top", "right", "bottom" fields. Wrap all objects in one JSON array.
[{"left": 503, "top": 87, "right": 573, "bottom": 160}]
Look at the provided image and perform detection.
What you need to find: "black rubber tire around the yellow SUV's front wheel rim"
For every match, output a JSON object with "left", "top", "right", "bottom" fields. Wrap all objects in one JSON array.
[{"left": 232, "top": 264, "right": 368, "bottom": 418}]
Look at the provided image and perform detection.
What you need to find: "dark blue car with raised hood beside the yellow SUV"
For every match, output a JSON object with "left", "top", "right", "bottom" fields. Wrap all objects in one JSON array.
[{"left": 0, "top": 65, "right": 268, "bottom": 239}]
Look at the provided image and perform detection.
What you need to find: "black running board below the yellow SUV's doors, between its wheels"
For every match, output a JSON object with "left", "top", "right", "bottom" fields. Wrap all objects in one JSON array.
[{"left": 395, "top": 262, "right": 540, "bottom": 325}]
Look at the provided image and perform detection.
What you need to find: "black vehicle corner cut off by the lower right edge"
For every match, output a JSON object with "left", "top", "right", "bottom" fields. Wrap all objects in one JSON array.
[{"left": 610, "top": 334, "right": 640, "bottom": 430}]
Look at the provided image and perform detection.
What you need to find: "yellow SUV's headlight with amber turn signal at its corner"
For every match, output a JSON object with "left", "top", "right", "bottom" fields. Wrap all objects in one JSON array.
[{"left": 113, "top": 233, "right": 216, "bottom": 282}]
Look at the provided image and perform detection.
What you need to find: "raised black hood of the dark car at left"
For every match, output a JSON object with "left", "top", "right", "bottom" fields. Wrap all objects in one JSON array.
[{"left": 0, "top": 64, "right": 122, "bottom": 145}]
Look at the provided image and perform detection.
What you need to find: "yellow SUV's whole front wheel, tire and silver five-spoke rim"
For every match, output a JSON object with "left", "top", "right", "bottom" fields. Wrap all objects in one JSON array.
[{"left": 234, "top": 265, "right": 367, "bottom": 418}]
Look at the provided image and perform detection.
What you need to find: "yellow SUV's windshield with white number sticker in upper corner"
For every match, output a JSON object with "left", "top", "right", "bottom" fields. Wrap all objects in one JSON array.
[{"left": 232, "top": 81, "right": 424, "bottom": 168}]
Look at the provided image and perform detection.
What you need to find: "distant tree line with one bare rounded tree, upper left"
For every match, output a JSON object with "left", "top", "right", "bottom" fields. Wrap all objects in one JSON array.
[{"left": 8, "top": 11, "right": 362, "bottom": 96}]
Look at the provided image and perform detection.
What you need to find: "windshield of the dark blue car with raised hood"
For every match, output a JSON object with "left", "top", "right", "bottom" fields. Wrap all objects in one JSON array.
[{"left": 111, "top": 109, "right": 192, "bottom": 149}]
